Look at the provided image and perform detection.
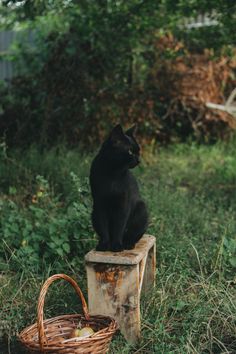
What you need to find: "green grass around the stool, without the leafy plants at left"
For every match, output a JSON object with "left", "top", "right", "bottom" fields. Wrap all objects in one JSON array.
[{"left": 0, "top": 140, "right": 236, "bottom": 354}]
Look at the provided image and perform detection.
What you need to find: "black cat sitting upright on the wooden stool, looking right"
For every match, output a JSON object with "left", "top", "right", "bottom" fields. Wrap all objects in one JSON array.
[{"left": 90, "top": 125, "right": 148, "bottom": 252}]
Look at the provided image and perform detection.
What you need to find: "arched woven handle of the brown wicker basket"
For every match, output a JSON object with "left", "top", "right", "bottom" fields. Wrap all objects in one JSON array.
[{"left": 37, "top": 274, "right": 89, "bottom": 350}]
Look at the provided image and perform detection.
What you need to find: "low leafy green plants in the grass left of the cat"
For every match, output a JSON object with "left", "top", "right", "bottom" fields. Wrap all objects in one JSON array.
[{"left": 0, "top": 172, "right": 95, "bottom": 270}]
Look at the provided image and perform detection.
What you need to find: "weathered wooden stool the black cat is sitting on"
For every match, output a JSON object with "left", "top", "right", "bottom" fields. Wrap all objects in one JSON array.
[{"left": 85, "top": 235, "right": 156, "bottom": 343}]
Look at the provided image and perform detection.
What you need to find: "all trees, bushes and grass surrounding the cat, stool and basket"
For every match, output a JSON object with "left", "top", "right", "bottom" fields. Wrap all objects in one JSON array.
[{"left": 0, "top": 0, "right": 236, "bottom": 354}]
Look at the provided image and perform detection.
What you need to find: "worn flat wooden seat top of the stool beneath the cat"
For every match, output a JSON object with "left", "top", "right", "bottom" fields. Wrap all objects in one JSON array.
[{"left": 85, "top": 235, "right": 156, "bottom": 265}]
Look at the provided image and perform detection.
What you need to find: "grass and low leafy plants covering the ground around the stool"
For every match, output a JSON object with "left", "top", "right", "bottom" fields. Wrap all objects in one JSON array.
[{"left": 0, "top": 140, "right": 236, "bottom": 354}]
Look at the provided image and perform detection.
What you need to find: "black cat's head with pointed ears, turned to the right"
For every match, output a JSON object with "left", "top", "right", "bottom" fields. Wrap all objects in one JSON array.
[{"left": 105, "top": 124, "right": 140, "bottom": 168}]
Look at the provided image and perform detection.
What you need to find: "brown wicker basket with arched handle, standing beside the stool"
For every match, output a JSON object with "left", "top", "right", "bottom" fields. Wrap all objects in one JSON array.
[{"left": 19, "top": 274, "right": 117, "bottom": 354}]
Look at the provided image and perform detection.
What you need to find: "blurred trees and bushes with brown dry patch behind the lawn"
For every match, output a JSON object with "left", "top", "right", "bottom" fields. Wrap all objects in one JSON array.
[{"left": 0, "top": 0, "right": 236, "bottom": 149}]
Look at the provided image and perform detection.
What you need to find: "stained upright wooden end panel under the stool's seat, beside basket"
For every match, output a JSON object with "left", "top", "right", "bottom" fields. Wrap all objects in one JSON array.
[{"left": 86, "top": 263, "right": 141, "bottom": 343}]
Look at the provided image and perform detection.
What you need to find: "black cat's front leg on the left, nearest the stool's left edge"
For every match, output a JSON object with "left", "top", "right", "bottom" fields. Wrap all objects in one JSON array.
[{"left": 92, "top": 206, "right": 110, "bottom": 251}]
